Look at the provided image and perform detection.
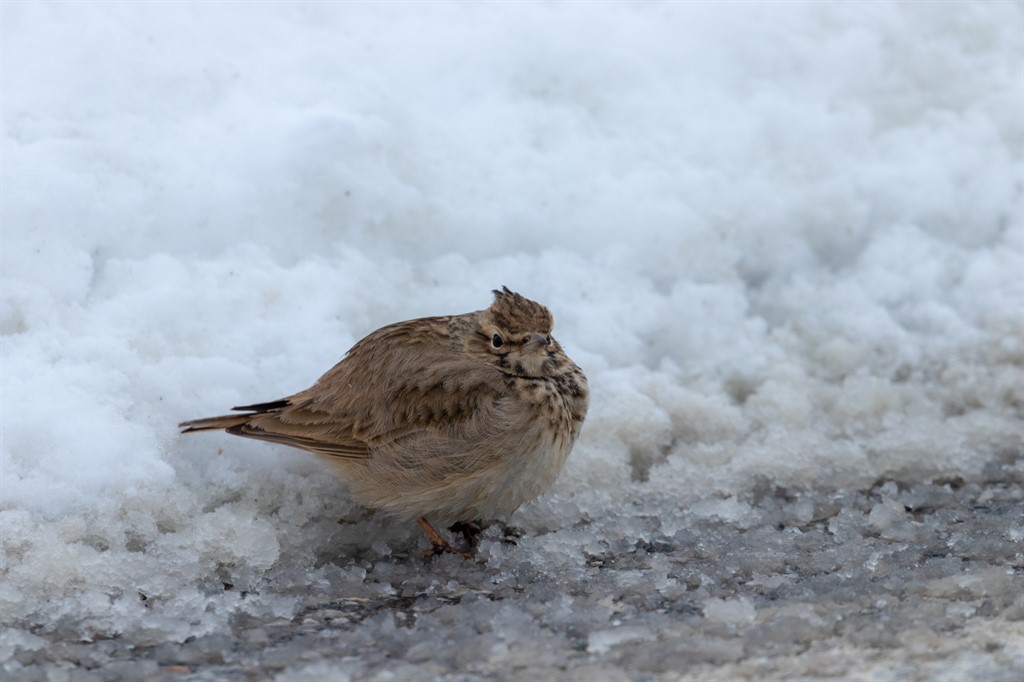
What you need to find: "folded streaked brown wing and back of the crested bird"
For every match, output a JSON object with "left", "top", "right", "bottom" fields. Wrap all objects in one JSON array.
[{"left": 235, "top": 317, "right": 511, "bottom": 458}]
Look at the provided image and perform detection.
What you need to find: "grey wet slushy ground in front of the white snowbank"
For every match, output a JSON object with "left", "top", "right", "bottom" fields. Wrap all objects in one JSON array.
[{"left": 5, "top": 461, "right": 1024, "bottom": 682}]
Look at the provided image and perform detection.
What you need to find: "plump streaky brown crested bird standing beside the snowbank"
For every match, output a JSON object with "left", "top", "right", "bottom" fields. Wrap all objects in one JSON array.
[{"left": 179, "top": 287, "right": 589, "bottom": 553}]
